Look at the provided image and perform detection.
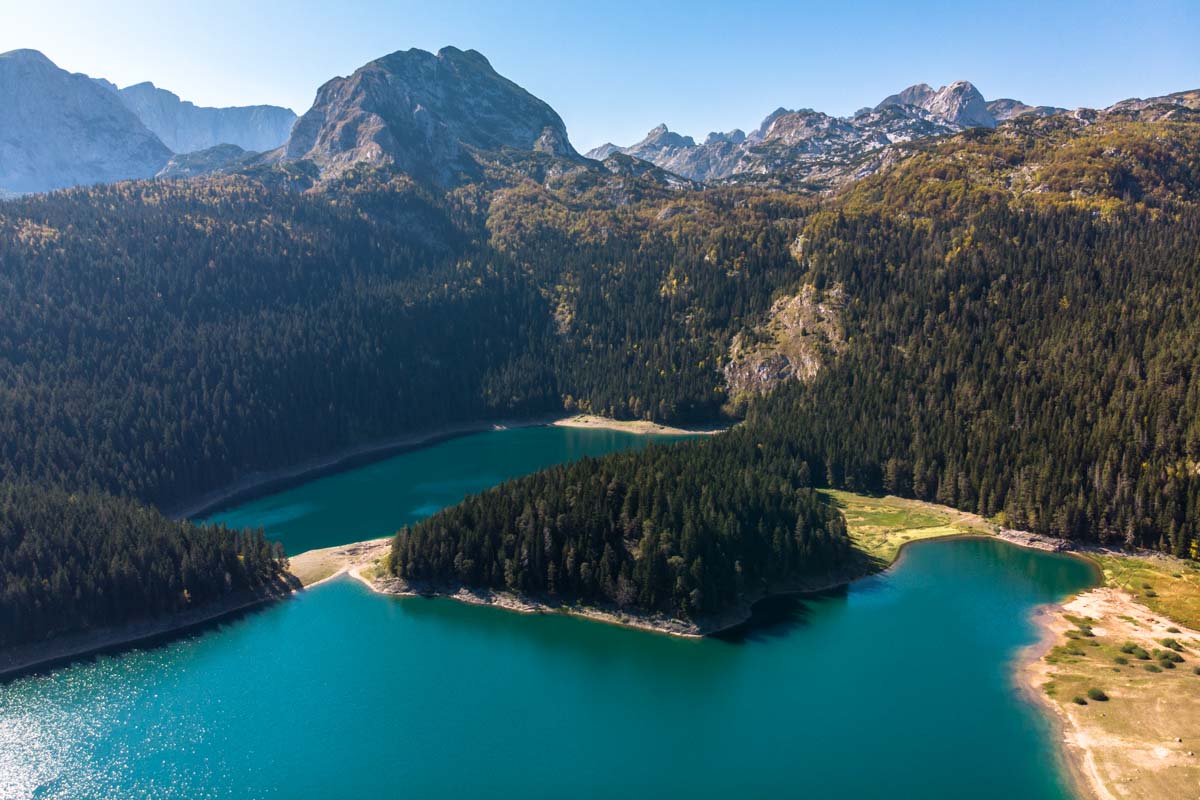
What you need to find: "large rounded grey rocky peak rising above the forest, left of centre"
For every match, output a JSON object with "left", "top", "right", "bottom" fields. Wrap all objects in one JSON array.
[{"left": 283, "top": 47, "right": 578, "bottom": 185}]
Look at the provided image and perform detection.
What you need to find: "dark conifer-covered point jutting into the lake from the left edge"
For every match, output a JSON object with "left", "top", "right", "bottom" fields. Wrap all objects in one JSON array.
[{"left": 0, "top": 485, "right": 283, "bottom": 646}]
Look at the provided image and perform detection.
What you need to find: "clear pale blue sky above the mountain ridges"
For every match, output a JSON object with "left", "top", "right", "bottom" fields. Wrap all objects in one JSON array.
[{"left": 0, "top": 0, "right": 1200, "bottom": 150}]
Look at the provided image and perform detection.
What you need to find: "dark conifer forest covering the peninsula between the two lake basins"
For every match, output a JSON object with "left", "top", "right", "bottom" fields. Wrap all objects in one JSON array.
[{"left": 389, "top": 428, "right": 851, "bottom": 618}]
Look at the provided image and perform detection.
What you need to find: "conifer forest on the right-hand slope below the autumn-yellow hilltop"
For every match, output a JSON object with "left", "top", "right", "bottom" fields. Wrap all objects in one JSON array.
[{"left": 749, "top": 199, "right": 1200, "bottom": 555}]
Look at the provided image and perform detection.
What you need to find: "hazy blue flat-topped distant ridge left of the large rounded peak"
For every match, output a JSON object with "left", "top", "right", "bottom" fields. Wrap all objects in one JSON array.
[{"left": 118, "top": 82, "right": 296, "bottom": 154}]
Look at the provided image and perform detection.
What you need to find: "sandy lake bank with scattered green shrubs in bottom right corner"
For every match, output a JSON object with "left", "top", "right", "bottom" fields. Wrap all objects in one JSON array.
[{"left": 1019, "top": 551, "right": 1200, "bottom": 800}]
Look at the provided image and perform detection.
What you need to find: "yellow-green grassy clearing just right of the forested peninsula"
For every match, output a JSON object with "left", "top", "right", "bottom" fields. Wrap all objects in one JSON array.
[{"left": 821, "top": 489, "right": 997, "bottom": 566}]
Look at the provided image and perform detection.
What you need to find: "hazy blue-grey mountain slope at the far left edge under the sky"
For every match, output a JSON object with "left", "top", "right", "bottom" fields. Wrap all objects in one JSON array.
[{"left": 0, "top": 50, "right": 172, "bottom": 193}]
